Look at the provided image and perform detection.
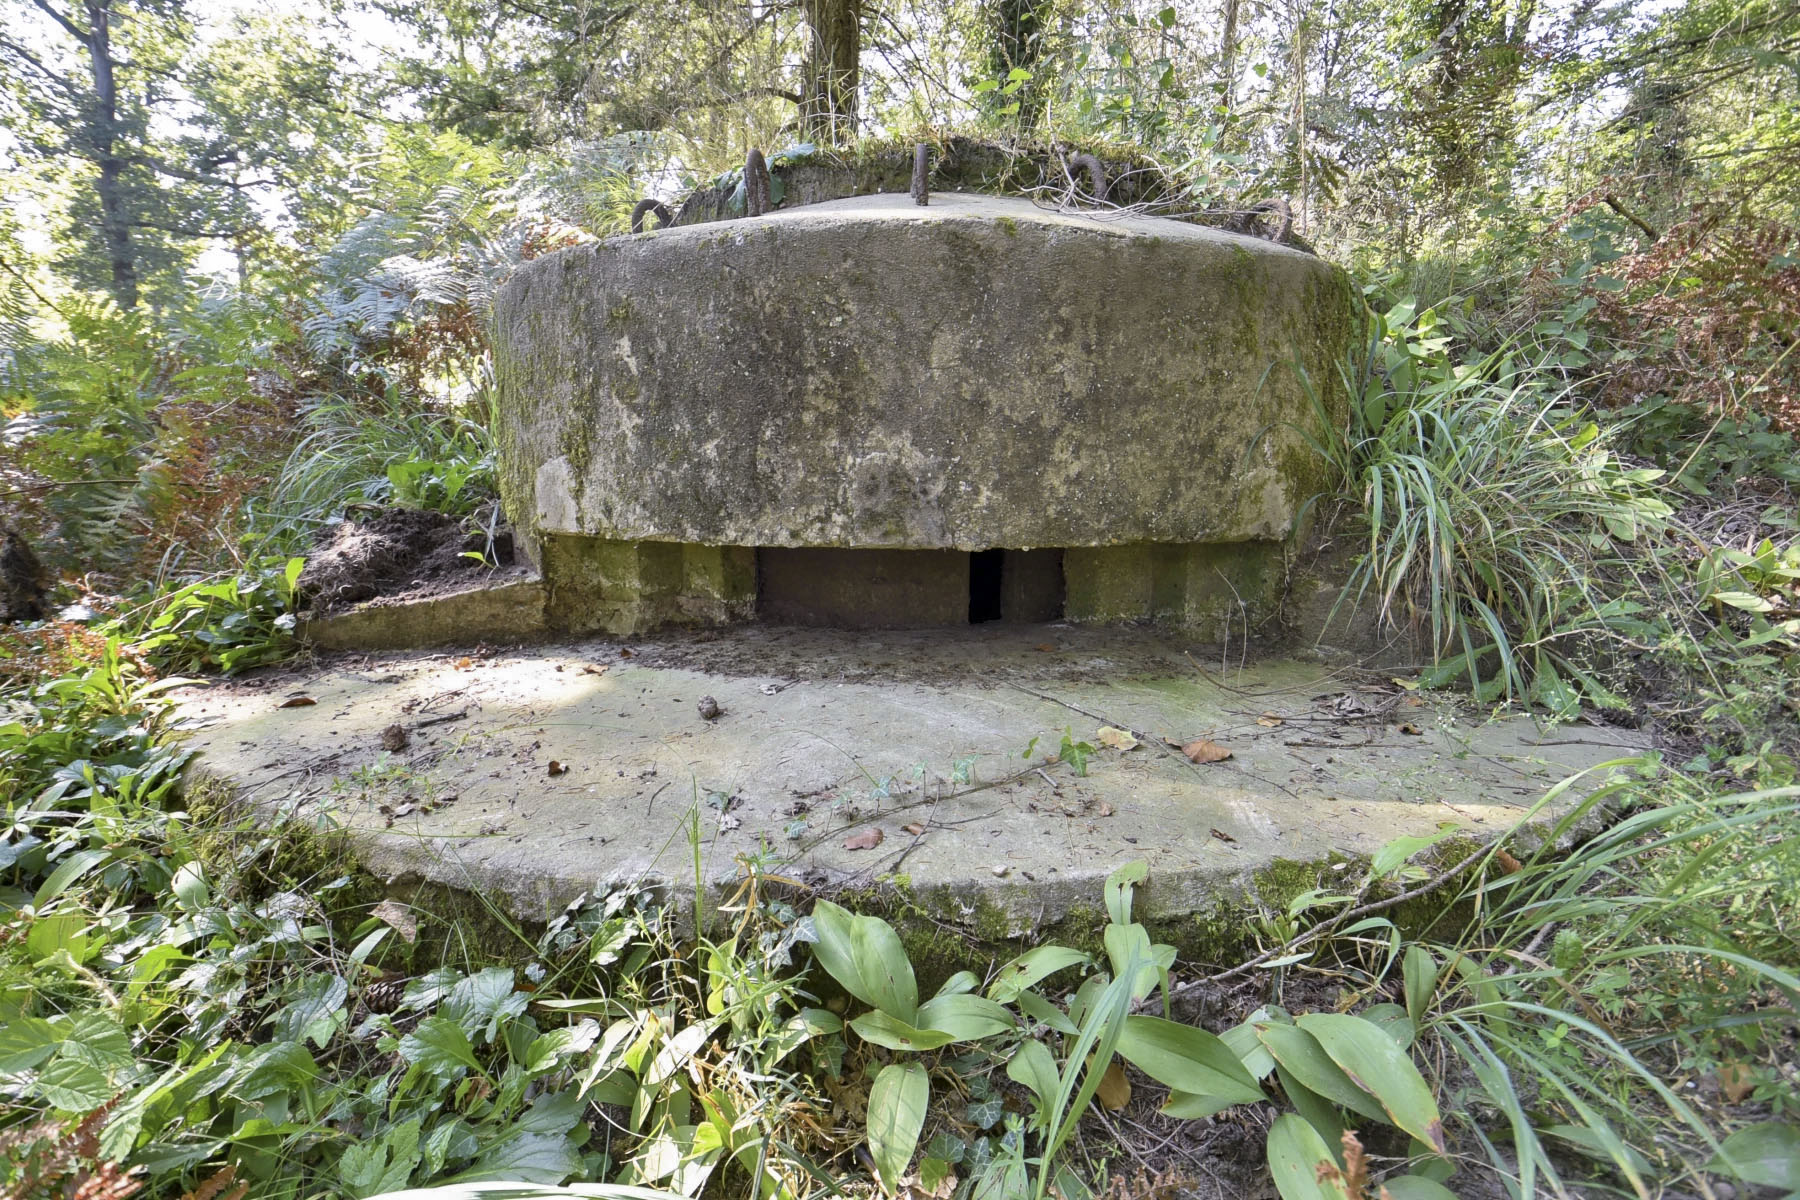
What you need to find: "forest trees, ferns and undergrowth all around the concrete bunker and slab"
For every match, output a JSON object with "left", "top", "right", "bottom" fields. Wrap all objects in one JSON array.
[{"left": 0, "top": 0, "right": 1800, "bottom": 1200}]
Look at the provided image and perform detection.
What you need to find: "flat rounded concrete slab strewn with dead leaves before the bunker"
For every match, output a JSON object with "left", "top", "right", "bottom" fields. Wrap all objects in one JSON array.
[{"left": 180, "top": 626, "right": 1643, "bottom": 937}]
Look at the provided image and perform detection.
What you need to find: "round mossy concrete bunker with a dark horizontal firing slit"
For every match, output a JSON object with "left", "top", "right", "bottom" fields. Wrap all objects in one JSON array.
[{"left": 493, "top": 193, "right": 1352, "bottom": 637}]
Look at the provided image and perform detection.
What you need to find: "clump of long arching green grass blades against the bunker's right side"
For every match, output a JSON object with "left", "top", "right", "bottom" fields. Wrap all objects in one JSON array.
[{"left": 1303, "top": 296, "right": 1670, "bottom": 712}]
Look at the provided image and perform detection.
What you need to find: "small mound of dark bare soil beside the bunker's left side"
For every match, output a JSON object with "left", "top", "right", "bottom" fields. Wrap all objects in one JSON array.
[{"left": 299, "top": 509, "right": 513, "bottom": 615}]
